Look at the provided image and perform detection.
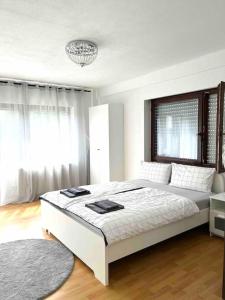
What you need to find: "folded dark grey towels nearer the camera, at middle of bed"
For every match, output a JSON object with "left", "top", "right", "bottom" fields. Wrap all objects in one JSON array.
[{"left": 85, "top": 200, "right": 124, "bottom": 214}]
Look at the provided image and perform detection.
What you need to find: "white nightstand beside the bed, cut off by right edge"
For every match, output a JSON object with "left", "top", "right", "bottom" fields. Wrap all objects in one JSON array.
[{"left": 209, "top": 193, "right": 225, "bottom": 237}]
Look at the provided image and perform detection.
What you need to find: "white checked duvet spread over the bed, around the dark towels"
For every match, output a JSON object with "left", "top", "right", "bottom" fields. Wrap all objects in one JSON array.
[{"left": 42, "top": 182, "right": 199, "bottom": 245}]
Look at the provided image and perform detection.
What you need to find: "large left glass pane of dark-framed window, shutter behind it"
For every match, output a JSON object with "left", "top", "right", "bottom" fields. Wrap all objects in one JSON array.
[{"left": 155, "top": 99, "right": 198, "bottom": 159}]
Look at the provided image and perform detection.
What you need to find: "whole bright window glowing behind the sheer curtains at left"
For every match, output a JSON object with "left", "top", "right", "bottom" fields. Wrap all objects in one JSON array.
[{"left": 0, "top": 104, "right": 78, "bottom": 170}]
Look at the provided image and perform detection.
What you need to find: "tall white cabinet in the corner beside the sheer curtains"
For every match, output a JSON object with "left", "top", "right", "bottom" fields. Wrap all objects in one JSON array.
[{"left": 89, "top": 103, "right": 124, "bottom": 184}]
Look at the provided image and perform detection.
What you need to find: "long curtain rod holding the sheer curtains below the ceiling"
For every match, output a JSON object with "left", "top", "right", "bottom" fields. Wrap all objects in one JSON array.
[{"left": 0, "top": 77, "right": 92, "bottom": 93}]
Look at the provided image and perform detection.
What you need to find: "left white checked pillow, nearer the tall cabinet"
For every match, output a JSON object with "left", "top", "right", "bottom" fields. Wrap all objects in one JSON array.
[{"left": 139, "top": 161, "right": 171, "bottom": 184}]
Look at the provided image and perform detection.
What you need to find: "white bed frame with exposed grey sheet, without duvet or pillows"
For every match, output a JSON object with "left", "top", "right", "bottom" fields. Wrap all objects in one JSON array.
[{"left": 41, "top": 174, "right": 225, "bottom": 285}]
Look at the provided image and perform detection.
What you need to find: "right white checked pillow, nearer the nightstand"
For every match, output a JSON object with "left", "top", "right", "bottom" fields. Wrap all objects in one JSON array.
[{"left": 170, "top": 163, "right": 215, "bottom": 192}]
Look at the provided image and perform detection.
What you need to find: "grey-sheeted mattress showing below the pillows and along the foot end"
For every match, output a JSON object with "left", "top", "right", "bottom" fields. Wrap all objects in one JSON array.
[{"left": 42, "top": 179, "right": 211, "bottom": 241}]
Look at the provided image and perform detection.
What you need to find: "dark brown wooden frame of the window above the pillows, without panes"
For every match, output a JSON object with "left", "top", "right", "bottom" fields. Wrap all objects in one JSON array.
[{"left": 151, "top": 86, "right": 218, "bottom": 171}]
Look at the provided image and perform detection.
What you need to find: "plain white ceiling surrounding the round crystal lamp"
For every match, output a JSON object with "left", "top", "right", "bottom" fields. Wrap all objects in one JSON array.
[{"left": 0, "top": 0, "right": 225, "bottom": 87}]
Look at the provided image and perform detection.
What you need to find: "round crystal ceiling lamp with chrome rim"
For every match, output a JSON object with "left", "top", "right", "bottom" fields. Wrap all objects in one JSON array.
[{"left": 66, "top": 40, "right": 98, "bottom": 67}]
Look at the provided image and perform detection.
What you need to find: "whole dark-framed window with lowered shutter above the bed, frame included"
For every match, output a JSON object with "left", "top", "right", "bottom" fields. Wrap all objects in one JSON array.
[{"left": 151, "top": 83, "right": 221, "bottom": 171}]
